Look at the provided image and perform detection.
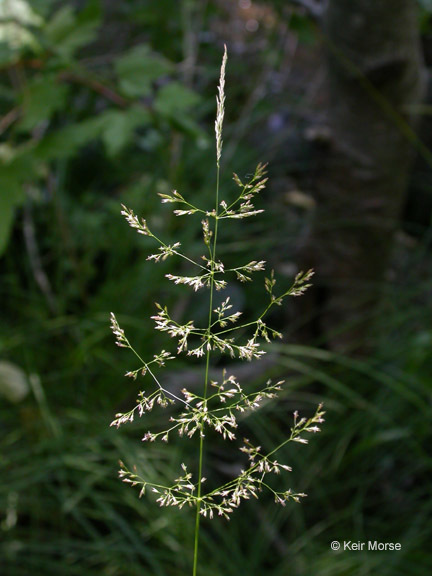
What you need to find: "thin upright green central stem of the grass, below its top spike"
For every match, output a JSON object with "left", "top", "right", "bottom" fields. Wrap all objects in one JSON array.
[{"left": 192, "top": 162, "right": 220, "bottom": 576}]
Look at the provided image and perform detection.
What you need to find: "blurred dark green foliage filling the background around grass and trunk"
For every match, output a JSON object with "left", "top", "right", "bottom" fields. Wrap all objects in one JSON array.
[{"left": 0, "top": 0, "right": 432, "bottom": 576}]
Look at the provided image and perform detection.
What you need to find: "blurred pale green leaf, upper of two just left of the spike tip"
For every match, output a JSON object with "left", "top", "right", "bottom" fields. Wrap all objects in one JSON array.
[{"left": 115, "top": 44, "right": 173, "bottom": 98}]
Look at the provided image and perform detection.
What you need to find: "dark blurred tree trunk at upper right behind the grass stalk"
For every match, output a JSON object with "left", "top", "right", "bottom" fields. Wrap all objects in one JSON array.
[{"left": 300, "top": 0, "right": 422, "bottom": 350}]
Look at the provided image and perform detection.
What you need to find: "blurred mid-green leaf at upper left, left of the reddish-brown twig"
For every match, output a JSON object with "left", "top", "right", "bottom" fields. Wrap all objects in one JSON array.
[{"left": 19, "top": 75, "right": 69, "bottom": 131}]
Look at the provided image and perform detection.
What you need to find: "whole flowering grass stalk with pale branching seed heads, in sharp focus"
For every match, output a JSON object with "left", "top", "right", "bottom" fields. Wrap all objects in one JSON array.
[{"left": 111, "top": 47, "right": 324, "bottom": 576}]
